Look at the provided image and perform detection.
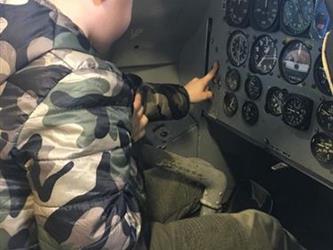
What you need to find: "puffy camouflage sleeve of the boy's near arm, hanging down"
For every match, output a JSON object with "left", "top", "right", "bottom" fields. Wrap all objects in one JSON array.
[{"left": 17, "top": 70, "right": 141, "bottom": 249}]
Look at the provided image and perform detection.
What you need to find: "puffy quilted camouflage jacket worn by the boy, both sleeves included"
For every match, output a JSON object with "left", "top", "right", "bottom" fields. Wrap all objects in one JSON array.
[{"left": 0, "top": 0, "right": 189, "bottom": 249}]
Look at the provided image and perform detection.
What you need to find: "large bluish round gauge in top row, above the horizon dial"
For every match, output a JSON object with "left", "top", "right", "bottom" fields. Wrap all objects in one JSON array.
[{"left": 281, "top": 0, "right": 314, "bottom": 36}]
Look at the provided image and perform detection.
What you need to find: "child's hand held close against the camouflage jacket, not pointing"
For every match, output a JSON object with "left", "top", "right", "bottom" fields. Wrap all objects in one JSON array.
[{"left": 132, "top": 93, "right": 148, "bottom": 142}]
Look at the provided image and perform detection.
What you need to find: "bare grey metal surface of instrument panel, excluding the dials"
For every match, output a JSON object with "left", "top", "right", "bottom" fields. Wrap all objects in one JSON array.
[{"left": 191, "top": 1, "right": 333, "bottom": 188}]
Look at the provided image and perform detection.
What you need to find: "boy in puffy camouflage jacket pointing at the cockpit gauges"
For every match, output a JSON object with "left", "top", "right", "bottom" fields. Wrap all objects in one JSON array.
[{"left": 0, "top": 0, "right": 301, "bottom": 249}]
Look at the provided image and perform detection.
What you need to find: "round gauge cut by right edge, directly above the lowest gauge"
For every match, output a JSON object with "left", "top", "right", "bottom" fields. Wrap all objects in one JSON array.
[{"left": 317, "top": 101, "right": 333, "bottom": 132}]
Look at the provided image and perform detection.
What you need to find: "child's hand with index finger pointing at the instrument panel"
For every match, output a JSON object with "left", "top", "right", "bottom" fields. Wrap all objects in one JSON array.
[{"left": 185, "top": 63, "right": 219, "bottom": 103}]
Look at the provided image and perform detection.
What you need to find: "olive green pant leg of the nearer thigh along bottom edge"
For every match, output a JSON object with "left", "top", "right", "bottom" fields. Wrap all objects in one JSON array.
[{"left": 149, "top": 210, "right": 304, "bottom": 250}]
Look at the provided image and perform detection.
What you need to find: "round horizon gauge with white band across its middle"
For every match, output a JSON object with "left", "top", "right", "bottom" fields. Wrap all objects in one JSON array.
[{"left": 280, "top": 41, "right": 311, "bottom": 84}]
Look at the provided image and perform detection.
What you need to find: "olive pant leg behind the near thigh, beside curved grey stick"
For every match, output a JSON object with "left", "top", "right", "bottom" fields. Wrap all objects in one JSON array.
[{"left": 144, "top": 168, "right": 202, "bottom": 223}]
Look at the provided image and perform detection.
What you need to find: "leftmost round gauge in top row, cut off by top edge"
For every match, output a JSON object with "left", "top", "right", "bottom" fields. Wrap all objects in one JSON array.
[{"left": 226, "top": 0, "right": 250, "bottom": 27}]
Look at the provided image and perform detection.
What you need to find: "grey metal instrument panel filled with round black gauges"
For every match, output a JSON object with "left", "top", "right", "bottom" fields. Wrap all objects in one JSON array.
[{"left": 208, "top": 0, "right": 333, "bottom": 188}]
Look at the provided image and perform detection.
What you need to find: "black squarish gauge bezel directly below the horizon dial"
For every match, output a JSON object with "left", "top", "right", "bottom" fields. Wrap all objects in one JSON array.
[{"left": 282, "top": 94, "right": 313, "bottom": 130}]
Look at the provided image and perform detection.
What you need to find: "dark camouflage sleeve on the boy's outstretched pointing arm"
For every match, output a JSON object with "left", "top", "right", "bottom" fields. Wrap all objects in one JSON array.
[{"left": 124, "top": 74, "right": 190, "bottom": 121}]
